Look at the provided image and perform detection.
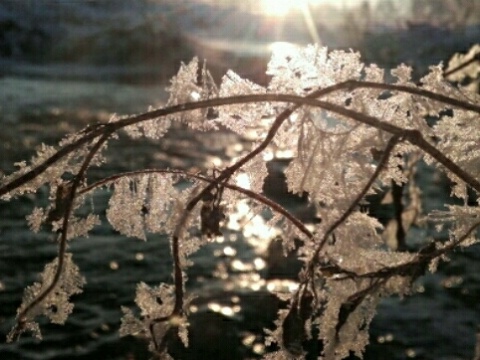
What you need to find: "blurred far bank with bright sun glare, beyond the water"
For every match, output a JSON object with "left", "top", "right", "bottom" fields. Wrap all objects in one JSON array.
[{"left": 0, "top": 0, "right": 480, "bottom": 84}]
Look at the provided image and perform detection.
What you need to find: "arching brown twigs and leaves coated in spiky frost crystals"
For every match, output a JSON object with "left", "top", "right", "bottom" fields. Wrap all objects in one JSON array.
[{"left": 0, "top": 46, "right": 480, "bottom": 360}]
